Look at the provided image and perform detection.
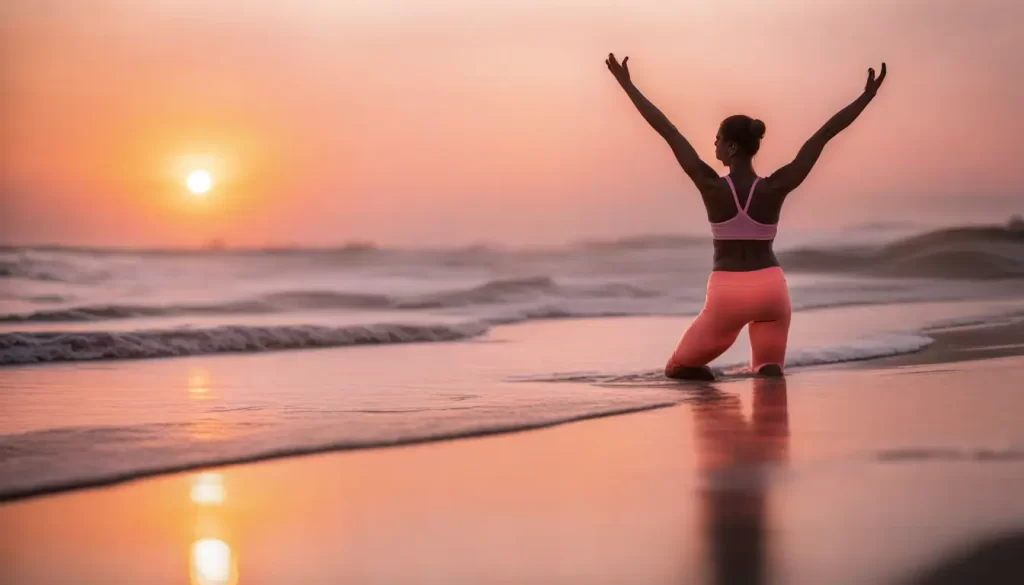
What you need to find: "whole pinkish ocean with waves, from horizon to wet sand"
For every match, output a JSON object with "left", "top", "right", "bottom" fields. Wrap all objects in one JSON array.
[{"left": 0, "top": 225, "right": 1024, "bottom": 498}]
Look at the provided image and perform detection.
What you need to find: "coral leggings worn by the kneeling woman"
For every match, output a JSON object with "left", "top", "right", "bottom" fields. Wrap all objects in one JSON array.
[{"left": 665, "top": 266, "right": 791, "bottom": 375}]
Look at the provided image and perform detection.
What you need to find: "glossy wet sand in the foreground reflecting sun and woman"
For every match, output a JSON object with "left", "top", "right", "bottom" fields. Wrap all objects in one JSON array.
[{"left": 0, "top": 311, "right": 1024, "bottom": 585}]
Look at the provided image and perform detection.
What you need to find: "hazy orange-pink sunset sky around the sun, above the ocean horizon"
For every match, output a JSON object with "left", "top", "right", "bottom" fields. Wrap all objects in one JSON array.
[{"left": 0, "top": 0, "right": 1024, "bottom": 247}]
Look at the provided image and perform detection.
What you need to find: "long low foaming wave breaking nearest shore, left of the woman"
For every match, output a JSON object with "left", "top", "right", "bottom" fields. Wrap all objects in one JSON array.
[{"left": 0, "top": 323, "right": 486, "bottom": 366}]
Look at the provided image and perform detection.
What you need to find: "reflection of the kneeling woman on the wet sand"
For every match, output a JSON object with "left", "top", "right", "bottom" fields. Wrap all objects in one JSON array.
[{"left": 693, "top": 378, "right": 790, "bottom": 584}]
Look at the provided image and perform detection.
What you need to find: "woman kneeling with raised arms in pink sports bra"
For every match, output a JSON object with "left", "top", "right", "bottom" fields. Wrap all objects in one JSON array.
[{"left": 605, "top": 54, "right": 886, "bottom": 380}]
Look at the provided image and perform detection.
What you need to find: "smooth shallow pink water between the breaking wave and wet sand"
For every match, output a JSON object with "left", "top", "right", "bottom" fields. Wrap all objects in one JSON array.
[{"left": 0, "top": 302, "right": 1019, "bottom": 498}]
